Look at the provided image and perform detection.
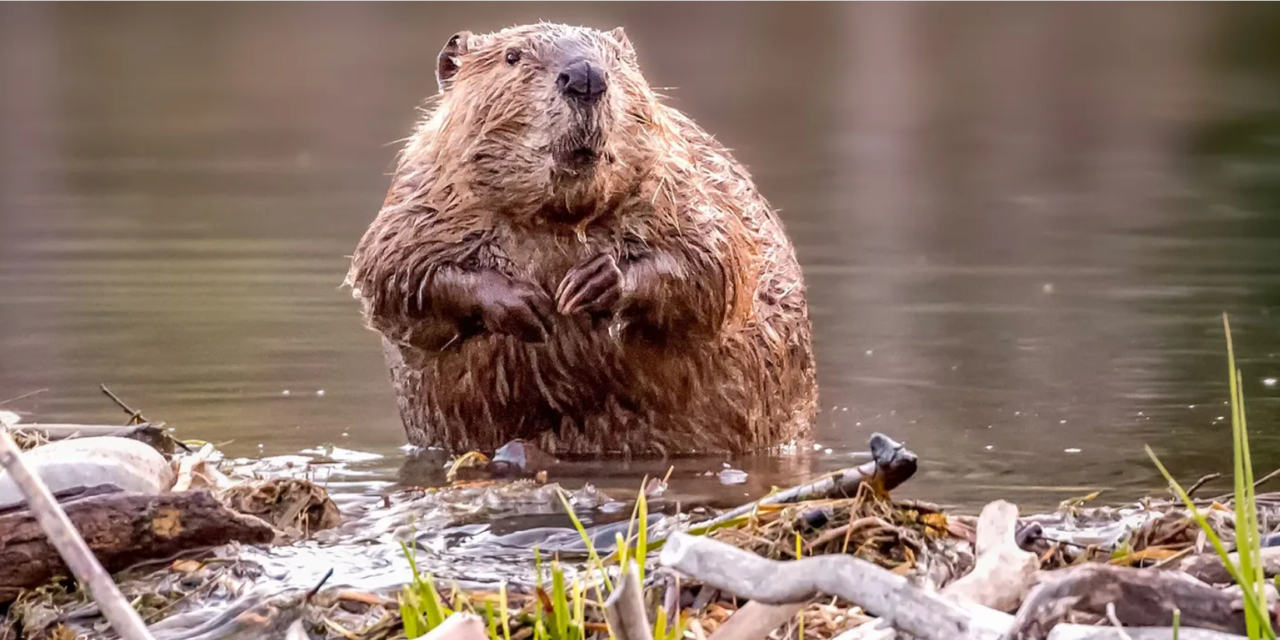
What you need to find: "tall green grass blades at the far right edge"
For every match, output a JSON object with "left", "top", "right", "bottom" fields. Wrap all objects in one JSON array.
[{"left": 1147, "top": 314, "right": 1276, "bottom": 640}]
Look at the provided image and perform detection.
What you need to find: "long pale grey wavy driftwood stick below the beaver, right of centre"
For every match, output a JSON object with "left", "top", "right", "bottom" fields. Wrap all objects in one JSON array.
[{"left": 659, "top": 532, "right": 1011, "bottom": 640}]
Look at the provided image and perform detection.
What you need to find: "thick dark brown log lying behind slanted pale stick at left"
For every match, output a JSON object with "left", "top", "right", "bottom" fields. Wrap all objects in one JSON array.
[{"left": 0, "top": 492, "right": 275, "bottom": 602}]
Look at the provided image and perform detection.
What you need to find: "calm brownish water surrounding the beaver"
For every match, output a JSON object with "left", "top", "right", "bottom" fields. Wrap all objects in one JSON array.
[{"left": 0, "top": 4, "right": 1280, "bottom": 506}]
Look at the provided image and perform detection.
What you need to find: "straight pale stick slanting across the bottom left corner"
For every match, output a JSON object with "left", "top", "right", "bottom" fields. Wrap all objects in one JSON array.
[{"left": 0, "top": 429, "right": 154, "bottom": 640}]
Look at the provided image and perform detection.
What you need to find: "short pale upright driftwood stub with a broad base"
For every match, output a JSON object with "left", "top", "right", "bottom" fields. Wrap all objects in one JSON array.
[{"left": 942, "top": 500, "right": 1039, "bottom": 612}]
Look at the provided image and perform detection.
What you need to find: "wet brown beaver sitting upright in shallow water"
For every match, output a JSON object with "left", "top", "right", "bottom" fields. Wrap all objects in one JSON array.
[{"left": 346, "top": 23, "right": 818, "bottom": 456}]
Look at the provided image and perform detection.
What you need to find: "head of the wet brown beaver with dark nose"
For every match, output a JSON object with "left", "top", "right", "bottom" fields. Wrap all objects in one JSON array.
[{"left": 426, "top": 23, "right": 655, "bottom": 221}]
